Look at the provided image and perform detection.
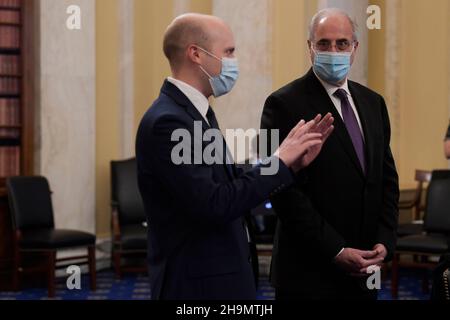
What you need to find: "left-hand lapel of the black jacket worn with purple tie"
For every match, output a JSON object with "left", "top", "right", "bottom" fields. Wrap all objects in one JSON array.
[{"left": 306, "top": 69, "right": 364, "bottom": 177}]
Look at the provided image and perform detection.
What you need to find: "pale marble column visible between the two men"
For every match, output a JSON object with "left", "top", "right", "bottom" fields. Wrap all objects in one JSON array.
[{"left": 213, "top": 0, "right": 272, "bottom": 162}]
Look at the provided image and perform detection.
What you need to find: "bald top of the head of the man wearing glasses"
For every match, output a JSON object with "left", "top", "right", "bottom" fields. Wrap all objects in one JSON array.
[{"left": 308, "top": 8, "right": 358, "bottom": 41}]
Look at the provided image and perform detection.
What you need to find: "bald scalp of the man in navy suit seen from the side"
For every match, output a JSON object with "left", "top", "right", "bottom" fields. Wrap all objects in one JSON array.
[{"left": 163, "top": 13, "right": 228, "bottom": 68}]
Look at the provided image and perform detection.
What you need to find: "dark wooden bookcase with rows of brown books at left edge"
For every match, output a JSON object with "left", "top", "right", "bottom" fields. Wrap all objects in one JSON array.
[{"left": 0, "top": 0, "right": 37, "bottom": 290}]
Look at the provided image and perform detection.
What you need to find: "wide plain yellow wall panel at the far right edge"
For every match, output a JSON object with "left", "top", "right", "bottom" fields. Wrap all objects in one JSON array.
[{"left": 397, "top": 0, "right": 450, "bottom": 186}]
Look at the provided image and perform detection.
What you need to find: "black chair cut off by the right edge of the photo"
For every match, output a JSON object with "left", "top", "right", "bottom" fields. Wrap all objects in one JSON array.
[{"left": 391, "top": 170, "right": 450, "bottom": 298}]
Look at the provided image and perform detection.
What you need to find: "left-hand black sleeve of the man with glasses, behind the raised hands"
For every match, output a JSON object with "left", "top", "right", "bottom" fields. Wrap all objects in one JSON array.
[{"left": 261, "top": 96, "right": 345, "bottom": 261}]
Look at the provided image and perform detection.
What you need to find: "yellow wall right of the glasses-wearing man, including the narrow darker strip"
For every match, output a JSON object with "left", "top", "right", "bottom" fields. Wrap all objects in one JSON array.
[{"left": 368, "top": 0, "right": 450, "bottom": 189}]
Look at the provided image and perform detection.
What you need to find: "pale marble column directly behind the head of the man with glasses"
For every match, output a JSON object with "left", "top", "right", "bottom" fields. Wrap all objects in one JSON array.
[{"left": 318, "top": 0, "right": 369, "bottom": 85}]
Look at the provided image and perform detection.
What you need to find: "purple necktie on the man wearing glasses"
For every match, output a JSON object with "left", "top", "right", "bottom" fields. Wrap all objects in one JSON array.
[{"left": 334, "top": 89, "right": 366, "bottom": 173}]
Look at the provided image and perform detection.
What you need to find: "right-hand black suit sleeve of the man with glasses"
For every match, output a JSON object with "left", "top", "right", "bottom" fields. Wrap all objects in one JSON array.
[{"left": 377, "top": 97, "right": 400, "bottom": 260}]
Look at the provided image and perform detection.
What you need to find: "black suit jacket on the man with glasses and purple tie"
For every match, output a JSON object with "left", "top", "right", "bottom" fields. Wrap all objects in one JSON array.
[{"left": 261, "top": 70, "right": 399, "bottom": 297}]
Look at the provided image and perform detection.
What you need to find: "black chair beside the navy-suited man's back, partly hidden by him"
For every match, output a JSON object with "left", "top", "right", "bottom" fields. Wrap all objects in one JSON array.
[{"left": 111, "top": 158, "right": 147, "bottom": 278}]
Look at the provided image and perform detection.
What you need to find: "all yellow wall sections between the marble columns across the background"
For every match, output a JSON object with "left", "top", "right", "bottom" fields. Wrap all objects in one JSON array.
[{"left": 92, "top": 0, "right": 450, "bottom": 235}]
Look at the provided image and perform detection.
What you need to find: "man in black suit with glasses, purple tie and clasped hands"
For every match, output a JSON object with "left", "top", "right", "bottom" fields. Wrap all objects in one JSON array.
[{"left": 261, "top": 9, "right": 399, "bottom": 299}]
